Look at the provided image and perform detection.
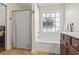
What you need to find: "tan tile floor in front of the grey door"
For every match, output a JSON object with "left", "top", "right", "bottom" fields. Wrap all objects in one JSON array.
[{"left": 0, "top": 49, "right": 48, "bottom": 55}]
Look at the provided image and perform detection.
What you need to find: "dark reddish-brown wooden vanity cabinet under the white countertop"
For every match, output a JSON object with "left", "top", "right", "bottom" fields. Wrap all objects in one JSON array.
[{"left": 60, "top": 33, "right": 79, "bottom": 55}]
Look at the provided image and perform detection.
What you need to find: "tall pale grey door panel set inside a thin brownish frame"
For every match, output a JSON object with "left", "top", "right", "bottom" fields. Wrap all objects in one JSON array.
[{"left": 13, "top": 10, "right": 31, "bottom": 49}]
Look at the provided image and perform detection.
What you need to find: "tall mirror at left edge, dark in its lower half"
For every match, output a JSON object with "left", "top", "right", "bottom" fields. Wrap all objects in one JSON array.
[{"left": 0, "top": 3, "right": 7, "bottom": 52}]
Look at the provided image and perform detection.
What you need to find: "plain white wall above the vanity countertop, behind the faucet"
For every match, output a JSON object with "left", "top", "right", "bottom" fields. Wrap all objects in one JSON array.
[{"left": 65, "top": 3, "right": 79, "bottom": 32}]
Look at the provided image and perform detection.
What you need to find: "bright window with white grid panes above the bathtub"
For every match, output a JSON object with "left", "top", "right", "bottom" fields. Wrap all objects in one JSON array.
[{"left": 42, "top": 12, "right": 61, "bottom": 32}]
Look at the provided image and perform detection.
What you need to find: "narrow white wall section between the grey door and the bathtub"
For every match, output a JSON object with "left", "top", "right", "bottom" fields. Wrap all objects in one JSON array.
[{"left": 32, "top": 4, "right": 39, "bottom": 52}]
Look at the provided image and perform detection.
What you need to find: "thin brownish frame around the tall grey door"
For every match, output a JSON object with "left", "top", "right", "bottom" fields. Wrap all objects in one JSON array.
[{"left": 12, "top": 9, "right": 32, "bottom": 50}]
